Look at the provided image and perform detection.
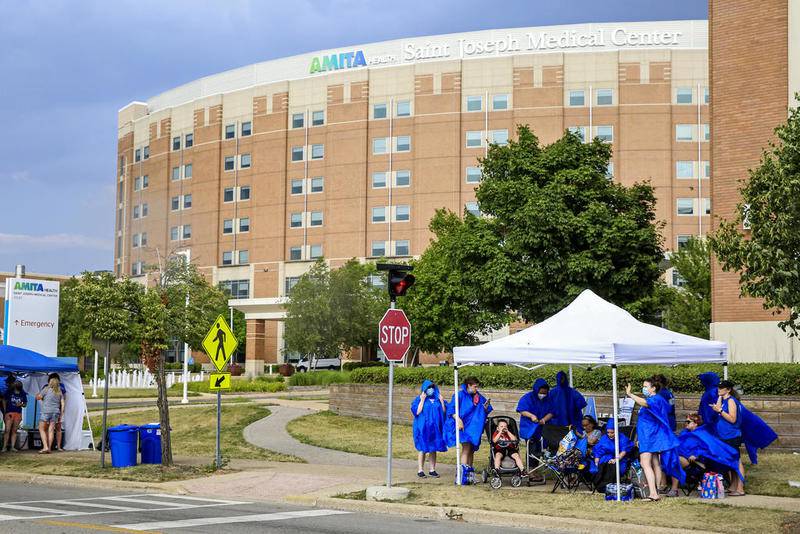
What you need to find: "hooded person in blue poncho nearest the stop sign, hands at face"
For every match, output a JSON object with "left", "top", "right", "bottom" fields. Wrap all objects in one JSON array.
[{"left": 411, "top": 380, "right": 447, "bottom": 478}]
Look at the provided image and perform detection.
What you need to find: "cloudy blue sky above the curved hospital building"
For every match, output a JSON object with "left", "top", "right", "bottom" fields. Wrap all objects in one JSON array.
[{"left": 0, "top": 0, "right": 707, "bottom": 274}]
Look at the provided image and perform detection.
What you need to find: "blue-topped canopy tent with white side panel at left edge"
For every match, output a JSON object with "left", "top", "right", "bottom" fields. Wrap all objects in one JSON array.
[{"left": 0, "top": 345, "right": 86, "bottom": 450}]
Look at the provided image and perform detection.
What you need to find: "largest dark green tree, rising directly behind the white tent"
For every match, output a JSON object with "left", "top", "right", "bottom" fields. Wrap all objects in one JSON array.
[{"left": 407, "top": 126, "right": 662, "bottom": 350}]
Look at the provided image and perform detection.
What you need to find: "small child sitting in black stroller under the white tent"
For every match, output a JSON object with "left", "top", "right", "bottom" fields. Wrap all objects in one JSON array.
[{"left": 484, "top": 417, "right": 528, "bottom": 489}]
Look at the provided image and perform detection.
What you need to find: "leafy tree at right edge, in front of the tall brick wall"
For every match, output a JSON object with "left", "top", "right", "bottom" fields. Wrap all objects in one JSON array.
[{"left": 711, "top": 102, "right": 800, "bottom": 336}]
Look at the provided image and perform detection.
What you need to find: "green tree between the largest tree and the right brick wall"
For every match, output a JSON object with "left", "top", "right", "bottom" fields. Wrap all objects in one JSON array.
[{"left": 664, "top": 238, "right": 711, "bottom": 339}]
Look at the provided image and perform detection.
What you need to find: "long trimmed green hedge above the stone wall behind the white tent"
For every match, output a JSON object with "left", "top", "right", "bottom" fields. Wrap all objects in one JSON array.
[{"left": 350, "top": 363, "right": 800, "bottom": 395}]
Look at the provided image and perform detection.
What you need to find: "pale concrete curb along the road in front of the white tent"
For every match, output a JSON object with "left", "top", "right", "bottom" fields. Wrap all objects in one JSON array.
[{"left": 284, "top": 495, "right": 712, "bottom": 534}]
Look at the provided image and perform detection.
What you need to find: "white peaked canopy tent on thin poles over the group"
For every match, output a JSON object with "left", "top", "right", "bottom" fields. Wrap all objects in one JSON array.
[{"left": 453, "top": 289, "right": 728, "bottom": 499}]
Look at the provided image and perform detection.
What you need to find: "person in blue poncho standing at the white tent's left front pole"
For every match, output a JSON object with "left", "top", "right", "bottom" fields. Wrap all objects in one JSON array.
[{"left": 444, "top": 377, "right": 493, "bottom": 466}]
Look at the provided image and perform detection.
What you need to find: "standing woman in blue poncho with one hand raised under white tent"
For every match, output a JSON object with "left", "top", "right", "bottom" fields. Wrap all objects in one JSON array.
[{"left": 625, "top": 378, "right": 686, "bottom": 501}]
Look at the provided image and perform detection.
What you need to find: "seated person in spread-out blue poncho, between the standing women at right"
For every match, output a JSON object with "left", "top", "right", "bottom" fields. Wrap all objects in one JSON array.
[{"left": 669, "top": 413, "right": 744, "bottom": 497}]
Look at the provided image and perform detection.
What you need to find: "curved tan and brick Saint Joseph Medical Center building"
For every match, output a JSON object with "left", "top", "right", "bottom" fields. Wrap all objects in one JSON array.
[{"left": 115, "top": 21, "right": 711, "bottom": 373}]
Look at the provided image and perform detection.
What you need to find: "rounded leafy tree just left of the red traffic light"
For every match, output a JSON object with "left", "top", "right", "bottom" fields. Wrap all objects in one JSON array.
[{"left": 284, "top": 259, "right": 388, "bottom": 358}]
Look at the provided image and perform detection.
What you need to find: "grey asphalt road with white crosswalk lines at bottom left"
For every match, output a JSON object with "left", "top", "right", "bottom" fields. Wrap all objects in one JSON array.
[{"left": 0, "top": 482, "right": 564, "bottom": 534}]
